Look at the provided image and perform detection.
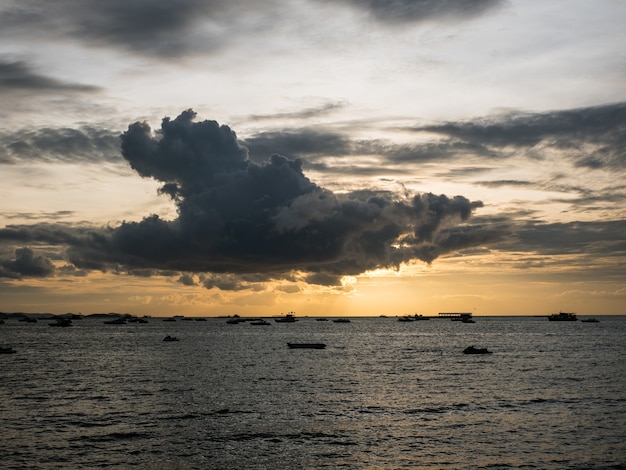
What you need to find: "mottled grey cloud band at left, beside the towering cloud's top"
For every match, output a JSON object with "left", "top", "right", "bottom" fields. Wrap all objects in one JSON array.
[{"left": 0, "top": 126, "right": 123, "bottom": 163}]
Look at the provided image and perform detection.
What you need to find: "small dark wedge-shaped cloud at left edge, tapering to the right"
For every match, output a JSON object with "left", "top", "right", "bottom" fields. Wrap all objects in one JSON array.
[{"left": 0, "top": 60, "right": 100, "bottom": 93}]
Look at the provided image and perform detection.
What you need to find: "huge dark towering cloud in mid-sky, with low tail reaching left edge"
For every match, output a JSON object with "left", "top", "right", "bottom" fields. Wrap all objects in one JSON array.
[{"left": 0, "top": 110, "right": 493, "bottom": 290}]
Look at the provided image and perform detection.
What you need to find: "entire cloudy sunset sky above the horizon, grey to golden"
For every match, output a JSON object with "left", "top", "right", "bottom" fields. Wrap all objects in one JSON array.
[{"left": 0, "top": 0, "right": 626, "bottom": 316}]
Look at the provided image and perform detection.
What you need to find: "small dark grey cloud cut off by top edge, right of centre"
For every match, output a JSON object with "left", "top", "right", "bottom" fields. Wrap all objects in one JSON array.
[{"left": 326, "top": 0, "right": 504, "bottom": 23}]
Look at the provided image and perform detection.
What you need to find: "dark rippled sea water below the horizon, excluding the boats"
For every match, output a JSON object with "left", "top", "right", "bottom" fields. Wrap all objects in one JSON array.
[{"left": 0, "top": 317, "right": 626, "bottom": 469}]
